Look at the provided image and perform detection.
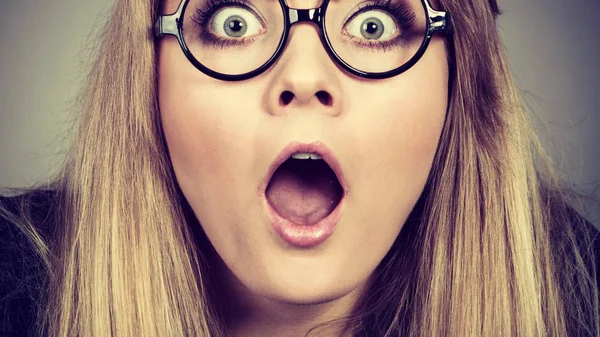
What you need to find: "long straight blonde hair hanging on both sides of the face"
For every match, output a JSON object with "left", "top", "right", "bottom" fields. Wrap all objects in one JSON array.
[{"left": 2, "top": 0, "right": 600, "bottom": 337}]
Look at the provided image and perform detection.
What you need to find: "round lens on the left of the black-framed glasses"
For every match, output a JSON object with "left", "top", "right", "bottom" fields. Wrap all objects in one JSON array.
[{"left": 183, "top": 0, "right": 285, "bottom": 75}]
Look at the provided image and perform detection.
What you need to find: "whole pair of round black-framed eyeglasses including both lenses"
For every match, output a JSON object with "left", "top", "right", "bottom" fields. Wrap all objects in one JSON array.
[{"left": 154, "top": 0, "right": 450, "bottom": 81}]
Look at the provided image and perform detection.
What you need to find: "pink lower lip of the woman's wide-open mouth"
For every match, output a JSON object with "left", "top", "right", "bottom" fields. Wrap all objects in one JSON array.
[{"left": 263, "top": 197, "right": 345, "bottom": 248}]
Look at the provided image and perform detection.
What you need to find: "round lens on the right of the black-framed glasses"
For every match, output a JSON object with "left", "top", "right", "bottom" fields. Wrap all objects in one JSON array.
[{"left": 324, "top": 0, "right": 428, "bottom": 73}]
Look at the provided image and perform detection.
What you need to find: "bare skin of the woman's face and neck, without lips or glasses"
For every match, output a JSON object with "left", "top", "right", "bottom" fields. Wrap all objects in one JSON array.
[{"left": 158, "top": 0, "right": 448, "bottom": 336}]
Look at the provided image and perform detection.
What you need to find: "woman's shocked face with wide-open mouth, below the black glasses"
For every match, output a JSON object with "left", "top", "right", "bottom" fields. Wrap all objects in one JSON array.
[{"left": 158, "top": 0, "right": 448, "bottom": 316}]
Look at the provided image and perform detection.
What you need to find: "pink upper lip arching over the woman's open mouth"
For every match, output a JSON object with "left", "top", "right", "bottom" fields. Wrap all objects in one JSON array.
[{"left": 259, "top": 141, "right": 348, "bottom": 197}]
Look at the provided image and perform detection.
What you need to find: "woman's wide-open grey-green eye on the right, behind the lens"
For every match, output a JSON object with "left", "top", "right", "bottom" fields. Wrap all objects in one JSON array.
[{"left": 344, "top": 10, "right": 399, "bottom": 41}]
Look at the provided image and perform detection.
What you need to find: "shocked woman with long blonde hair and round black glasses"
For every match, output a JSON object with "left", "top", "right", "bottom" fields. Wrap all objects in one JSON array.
[{"left": 1, "top": 0, "right": 600, "bottom": 336}]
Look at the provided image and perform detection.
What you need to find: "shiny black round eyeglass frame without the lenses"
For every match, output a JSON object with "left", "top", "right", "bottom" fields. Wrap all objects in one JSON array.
[{"left": 154, "top": 0, "right": 451, "bottom": 81}]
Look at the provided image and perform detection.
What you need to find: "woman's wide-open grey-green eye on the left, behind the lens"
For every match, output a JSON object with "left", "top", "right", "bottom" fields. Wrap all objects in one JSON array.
[{"left": 210, "top": 7, "right": 265, "bottom": 38}]
